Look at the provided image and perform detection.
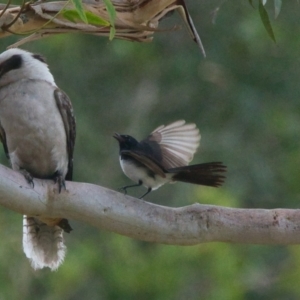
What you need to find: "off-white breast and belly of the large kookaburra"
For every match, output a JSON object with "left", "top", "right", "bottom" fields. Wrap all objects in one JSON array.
[{"left": 0, "top": 80, "right": 68, "bottom": 178}]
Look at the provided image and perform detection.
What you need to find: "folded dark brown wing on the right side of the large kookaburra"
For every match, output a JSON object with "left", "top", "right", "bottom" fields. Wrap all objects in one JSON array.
[{"left": 54, "top": 89, "right": 76, "bottom": 180}]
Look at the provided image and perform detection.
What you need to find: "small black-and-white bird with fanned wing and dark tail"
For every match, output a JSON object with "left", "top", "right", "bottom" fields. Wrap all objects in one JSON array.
[{"left": 114, "top": 120, "right": 226, "bottom": 198}]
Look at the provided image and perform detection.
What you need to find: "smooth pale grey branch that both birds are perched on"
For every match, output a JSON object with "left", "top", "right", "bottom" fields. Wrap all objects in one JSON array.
[{"left": 0, "top": 165, "right": 300, "bottom": 245}]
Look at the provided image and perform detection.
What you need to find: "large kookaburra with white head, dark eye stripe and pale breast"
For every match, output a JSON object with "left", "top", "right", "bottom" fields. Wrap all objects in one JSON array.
[{"left": 0, "top": 49, "right": 76, "bottom": 270}]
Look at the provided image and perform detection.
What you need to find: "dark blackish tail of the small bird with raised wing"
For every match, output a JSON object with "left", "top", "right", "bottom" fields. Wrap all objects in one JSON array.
[{"left": 168, "top": 162, "right": 226, "bottom": 187}]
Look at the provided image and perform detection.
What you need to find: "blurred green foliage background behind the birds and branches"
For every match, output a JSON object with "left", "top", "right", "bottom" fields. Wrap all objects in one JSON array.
[{"left": 0, "top": 0, "right": 300, "bottom": 300}]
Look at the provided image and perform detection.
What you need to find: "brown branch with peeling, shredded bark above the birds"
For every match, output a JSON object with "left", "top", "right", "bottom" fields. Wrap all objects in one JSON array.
[{"left": 0, "top": 0, "right": 204, "bottom": 49}]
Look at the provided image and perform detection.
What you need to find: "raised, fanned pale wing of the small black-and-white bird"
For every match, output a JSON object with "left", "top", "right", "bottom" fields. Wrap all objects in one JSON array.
[{"left": 142, "top": 120, "right": 200, "bottom": 169}]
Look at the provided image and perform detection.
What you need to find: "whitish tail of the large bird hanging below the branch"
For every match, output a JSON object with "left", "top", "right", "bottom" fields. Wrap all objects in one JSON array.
[{"left": 23, "top": 216, "right": 66, "bottom": 271}]
